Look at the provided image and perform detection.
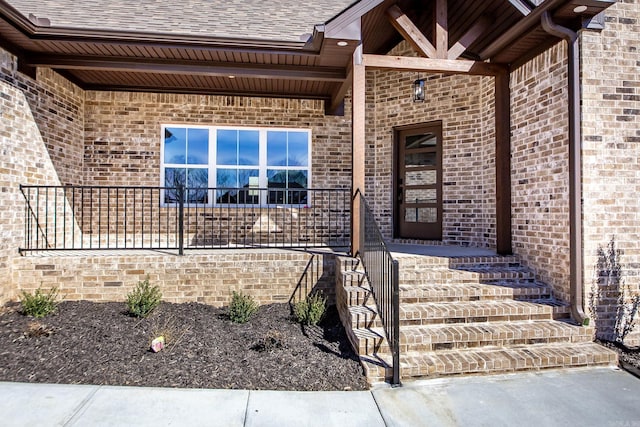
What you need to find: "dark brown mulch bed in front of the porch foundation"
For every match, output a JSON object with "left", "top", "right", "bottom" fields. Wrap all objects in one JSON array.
[{"left": 0, "top": 301, "right": 368, "bottom": 390}]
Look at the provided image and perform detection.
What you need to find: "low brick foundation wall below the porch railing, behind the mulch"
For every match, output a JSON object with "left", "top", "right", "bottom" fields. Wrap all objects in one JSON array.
[{"left": 13, "top": 250, "right": 335, "bottom": 307}]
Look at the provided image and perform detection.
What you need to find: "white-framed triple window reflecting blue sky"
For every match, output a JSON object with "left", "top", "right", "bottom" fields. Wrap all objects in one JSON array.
[{"left": 161, "top": 125, "right": 311, "bottom": 205}]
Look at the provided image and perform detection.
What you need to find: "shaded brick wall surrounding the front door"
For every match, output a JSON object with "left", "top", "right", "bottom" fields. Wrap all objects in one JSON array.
[{"left": 367, "top": 42, "right": 495, "bottom": 247}]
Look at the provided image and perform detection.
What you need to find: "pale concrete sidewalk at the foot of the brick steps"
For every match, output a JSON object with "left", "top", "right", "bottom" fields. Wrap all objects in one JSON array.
[{"left": 0, "top": 368, "right": 640, "bottom": 427}]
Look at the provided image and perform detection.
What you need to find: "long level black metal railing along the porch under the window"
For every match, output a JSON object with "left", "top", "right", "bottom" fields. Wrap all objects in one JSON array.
[{"left": 20, "top": 186, "right": 351, "bottom": 254}]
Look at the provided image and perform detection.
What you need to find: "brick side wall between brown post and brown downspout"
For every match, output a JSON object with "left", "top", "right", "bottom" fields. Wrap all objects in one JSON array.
[{"left": 511, "top": 42, "right": 569, "bottom": 301}]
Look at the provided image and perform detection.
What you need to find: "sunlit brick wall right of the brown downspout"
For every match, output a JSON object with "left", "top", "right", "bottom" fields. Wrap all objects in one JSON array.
[{"left": 581, "top": 0, "right": 640, "bottom": 346}]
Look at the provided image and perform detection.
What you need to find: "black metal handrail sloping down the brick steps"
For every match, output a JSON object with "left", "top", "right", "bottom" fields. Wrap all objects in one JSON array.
[{"left": 355, "top": 192, "right": 400, "bottom": 385}]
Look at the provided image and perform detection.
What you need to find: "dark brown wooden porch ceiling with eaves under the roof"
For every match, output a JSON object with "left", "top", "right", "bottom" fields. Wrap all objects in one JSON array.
[{"left": 0, "top": 0, "right": 613, "bottom": 113}]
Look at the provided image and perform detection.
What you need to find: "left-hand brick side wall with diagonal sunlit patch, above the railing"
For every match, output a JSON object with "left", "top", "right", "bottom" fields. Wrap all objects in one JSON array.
[{"left": 0, "top": 50, "right": 81, "bottom": 304}]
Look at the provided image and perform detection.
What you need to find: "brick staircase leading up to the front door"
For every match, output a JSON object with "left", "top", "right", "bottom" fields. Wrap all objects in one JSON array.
[{"left": 336, "top": 255, "right": 617, "bottom": 383}]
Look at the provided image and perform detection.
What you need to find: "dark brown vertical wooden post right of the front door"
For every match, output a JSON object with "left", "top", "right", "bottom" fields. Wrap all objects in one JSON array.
[{"left": 495, "top": 72, "right": 512, "bottom": 255}]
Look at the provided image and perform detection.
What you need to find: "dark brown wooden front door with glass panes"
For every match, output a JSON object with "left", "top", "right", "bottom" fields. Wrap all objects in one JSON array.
[{"left": 395, "top": 123, "right": 442, "bottom": 240}]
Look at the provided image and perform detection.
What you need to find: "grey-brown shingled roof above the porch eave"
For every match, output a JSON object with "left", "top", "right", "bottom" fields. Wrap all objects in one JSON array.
[{"left": 7, "top": 0, "right": 354, "bottom": 42}]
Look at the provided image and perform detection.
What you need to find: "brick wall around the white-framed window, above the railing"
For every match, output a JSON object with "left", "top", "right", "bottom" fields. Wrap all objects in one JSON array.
[{"left": 84, "top": 92, "right": 351, "bottom": 188}]
